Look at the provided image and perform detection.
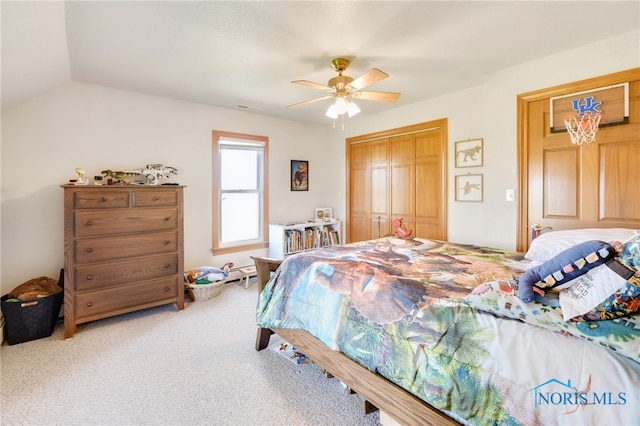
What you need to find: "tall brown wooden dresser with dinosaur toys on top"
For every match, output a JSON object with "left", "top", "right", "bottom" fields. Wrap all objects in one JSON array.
[{"left": 63, "top": 185, "right": 184, "bottom": 338}]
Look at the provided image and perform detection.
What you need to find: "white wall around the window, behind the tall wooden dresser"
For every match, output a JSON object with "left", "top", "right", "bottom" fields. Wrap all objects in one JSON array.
[{"left": 2, "top": 83, "right": 336, "bottom": 294}]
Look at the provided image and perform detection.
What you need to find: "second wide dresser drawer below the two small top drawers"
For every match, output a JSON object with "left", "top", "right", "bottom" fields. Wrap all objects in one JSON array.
[{"left": 75, "top": 231, "right": 178, "bottom": 265}]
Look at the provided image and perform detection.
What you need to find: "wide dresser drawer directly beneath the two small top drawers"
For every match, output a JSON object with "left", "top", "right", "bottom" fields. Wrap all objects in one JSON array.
[{"left": 75, "top": 208, "right": 178, "bottom": 237}]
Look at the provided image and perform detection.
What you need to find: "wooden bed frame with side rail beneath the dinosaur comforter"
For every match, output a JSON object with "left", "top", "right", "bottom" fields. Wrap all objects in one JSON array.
[{"left": 253, "top": 256, "right": 459, "bottom": 426}]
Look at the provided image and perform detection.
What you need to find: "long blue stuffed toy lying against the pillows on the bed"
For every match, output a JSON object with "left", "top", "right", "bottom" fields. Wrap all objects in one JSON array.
[{"left": 518, "top": 240, "right": 616, "bottom": 303}]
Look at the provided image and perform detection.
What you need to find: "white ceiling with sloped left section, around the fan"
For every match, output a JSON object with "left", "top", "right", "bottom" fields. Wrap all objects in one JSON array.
[{"left": 2, "top": 0, "right": 640, "bottom": 124}]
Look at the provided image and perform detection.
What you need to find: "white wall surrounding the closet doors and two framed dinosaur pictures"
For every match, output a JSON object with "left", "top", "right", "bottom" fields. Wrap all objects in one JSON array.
[{"left": 333, "top": 31, "right": 640, "bottom": 250}]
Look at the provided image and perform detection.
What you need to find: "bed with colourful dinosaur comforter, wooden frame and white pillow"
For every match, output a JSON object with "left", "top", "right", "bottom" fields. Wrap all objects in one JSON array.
[{"left": 254, "top": 229, "right": 640, "bottom": 425}]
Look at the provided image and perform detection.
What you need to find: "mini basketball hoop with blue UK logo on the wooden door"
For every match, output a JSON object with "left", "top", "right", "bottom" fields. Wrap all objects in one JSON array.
[{"left": 549, "top": 83, "right": 629, "bottom": 145}]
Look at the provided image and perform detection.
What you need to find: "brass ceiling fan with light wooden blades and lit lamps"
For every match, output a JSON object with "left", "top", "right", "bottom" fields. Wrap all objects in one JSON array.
[{"left": 287, "top": 58, "right": 400, "bottom": 119}]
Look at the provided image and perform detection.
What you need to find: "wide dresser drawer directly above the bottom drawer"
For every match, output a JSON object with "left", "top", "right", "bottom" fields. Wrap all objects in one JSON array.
[{"left": 75, "top": 253, "right": 178, "bottom": 291}]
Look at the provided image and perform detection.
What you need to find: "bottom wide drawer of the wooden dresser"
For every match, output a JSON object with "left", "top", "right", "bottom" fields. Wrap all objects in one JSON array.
[{"left": 75, "top": 277, "right": 179, "bottom": 322}]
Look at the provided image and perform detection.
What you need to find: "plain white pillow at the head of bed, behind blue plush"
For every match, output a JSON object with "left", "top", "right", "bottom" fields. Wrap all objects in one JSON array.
[{"left": 524, "top": 228, "right": 638, "bottom": 262}]
